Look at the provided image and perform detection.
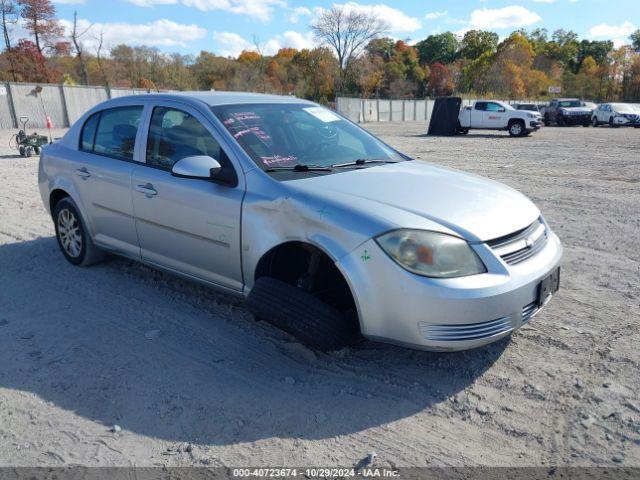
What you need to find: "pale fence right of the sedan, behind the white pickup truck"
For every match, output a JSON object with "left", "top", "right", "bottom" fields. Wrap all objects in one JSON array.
[{"left": 336, "top": 97, "right": 546, "bottom": 123}]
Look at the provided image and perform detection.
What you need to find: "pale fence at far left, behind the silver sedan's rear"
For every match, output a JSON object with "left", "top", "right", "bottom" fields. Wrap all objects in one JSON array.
[{"left": 0, "top": 82, "right": 153, "bottom": 129}]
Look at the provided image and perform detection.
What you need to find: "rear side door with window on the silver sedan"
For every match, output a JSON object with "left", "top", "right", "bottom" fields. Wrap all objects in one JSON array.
[{"left": 72, "top": 105, "right": 143, "bottom": 258}]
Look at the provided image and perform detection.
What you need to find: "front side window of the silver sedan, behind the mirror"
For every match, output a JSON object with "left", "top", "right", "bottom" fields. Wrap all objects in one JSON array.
[{"left": 147, "top": 107, "right": 230, "bottom": 170}]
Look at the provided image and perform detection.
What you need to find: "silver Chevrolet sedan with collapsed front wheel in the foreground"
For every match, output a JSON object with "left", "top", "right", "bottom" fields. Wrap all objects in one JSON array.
[{"left": 38, "top": 92, "right": 562, "bottom": 350}]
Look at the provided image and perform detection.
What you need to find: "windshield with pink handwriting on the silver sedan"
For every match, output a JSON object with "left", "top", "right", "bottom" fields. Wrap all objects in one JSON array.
[{"left": 211, "top": 103, "right": 407, "bottom": 171}]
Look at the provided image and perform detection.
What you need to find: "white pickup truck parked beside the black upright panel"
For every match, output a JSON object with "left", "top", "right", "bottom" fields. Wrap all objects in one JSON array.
[{"left": 458, "top": 100, "right": 542, "bottom": 137}]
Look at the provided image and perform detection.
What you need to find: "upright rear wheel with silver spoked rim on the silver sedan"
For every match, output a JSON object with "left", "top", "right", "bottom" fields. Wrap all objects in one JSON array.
[{"left": 53, "top": 197, "right": 104, "bottom": 266}]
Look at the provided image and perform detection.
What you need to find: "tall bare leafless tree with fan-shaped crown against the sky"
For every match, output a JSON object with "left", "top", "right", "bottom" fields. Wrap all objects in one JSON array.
[{"left": 311, "top": 5, "right": 389, "bottom": 92}]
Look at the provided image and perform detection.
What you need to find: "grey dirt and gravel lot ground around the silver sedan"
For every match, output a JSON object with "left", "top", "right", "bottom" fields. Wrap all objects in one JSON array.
[{"left": 0, "top": 124, "right": 640, "bottom": 466}]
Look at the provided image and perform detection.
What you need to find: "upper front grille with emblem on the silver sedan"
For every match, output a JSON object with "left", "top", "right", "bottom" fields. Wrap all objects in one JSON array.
[{"left": 487, "top": 219, "right": 548, "bottom": 265}]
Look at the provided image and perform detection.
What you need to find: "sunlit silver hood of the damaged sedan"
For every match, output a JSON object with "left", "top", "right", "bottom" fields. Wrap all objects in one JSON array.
[{"left": 287, "top": 160, "right": 540, "bottom": 241}]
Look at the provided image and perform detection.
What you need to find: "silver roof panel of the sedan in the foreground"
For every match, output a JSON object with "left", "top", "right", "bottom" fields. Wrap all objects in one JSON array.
[{"left": 110, "top": 91, "right": 313, "bottom": 106}]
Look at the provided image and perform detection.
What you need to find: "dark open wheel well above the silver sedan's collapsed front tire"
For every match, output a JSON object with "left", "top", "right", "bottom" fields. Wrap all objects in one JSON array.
[{"left": 254, "top": 242, "right": 358, "bottom": 323}]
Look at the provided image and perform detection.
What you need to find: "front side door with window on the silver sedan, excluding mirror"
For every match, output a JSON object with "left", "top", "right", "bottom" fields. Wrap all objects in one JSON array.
[{"left": 132, "top": 102, "right": 244, "bottom": 291}]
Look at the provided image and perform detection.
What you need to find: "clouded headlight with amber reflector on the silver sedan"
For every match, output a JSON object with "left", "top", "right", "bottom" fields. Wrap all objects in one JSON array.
[{"left": 375, "top": 229, "right": 487, "bottom": 278}]
